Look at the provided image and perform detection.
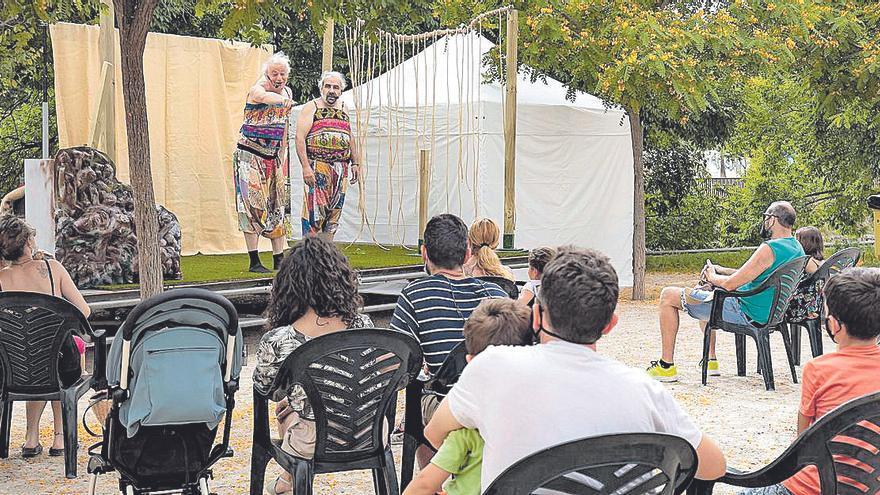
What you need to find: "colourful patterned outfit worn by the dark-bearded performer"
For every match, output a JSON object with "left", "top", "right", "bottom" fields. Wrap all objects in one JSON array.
[{"left": 302, "top": 104, "right": 351, "bottom": 236}]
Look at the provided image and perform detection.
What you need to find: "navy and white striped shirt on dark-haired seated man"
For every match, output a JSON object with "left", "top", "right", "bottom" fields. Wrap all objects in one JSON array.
[{"left": 391, "top": 275, "right": 508, "bottom": 375}]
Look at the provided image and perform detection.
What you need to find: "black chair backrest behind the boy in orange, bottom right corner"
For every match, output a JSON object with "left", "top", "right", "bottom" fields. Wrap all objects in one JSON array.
[{"left": 774, "top": 393, "right": 880, "bottom": 494}]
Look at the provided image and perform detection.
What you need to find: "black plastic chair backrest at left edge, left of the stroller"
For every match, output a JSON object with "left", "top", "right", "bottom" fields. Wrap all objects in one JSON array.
[{"left": 0, "top": 291, "right": 92, "bottom": 393}]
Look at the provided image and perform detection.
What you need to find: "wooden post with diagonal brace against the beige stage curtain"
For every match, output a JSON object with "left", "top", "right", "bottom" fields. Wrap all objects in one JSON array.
[{"left": 95, "top": 0, "right": 117, "bottom": 163}]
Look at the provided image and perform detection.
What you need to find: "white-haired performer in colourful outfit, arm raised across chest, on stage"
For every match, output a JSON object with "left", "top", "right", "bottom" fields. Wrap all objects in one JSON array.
[{"left": 232, "top": 52, "right": 293, "bottom": 273}]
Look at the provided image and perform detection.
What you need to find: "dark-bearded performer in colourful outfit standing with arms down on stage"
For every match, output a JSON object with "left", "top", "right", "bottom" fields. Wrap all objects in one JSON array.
[{"left": 296, "top": 72, "right": 360, "bottom": 240}]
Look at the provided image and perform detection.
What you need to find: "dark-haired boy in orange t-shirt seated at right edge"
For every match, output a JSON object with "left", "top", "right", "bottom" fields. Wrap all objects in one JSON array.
[{"left": 740, "top": 268, "right": 880, "bottom": 495}]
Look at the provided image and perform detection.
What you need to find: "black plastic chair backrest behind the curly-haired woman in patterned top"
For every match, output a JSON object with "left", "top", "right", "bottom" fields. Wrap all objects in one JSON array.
[{"left": 268, "top": 328, "right": 422, "bottom": 462}]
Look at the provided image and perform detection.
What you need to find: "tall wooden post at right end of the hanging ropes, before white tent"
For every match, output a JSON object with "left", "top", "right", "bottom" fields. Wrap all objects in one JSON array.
[{"left": 502, "top": 9, "right": 519, "bottom": 249}]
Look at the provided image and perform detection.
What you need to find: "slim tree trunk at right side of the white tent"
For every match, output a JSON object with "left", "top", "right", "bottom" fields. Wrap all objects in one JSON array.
[{"left": 627, "top": 108, "right": 645, "bottom": 301}]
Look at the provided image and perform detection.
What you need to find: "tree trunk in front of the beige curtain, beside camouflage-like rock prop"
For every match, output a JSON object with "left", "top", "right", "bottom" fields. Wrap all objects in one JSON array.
[{"left": 113, "top": 0, "right": 162, "bottom": 299}]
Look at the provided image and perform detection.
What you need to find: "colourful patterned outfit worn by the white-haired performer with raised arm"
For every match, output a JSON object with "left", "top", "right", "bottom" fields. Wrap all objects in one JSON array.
[{"left": 232, "top": 93, "right": 291, "bottom": 239}]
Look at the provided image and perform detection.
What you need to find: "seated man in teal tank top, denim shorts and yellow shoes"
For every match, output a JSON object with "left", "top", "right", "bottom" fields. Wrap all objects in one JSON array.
[{"left": 648, "top": 201, "right": 804, "bottom": 382}]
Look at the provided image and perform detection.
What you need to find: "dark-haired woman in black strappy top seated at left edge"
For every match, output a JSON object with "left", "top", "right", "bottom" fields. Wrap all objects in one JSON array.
[{"left": 0, "top": 215, "right": 91, "bottom": 458}]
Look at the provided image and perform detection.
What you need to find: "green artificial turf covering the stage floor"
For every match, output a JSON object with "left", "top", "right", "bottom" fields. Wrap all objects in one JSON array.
[{"left": 101, "top": 243, "right": 525, "bottom": 289}]
